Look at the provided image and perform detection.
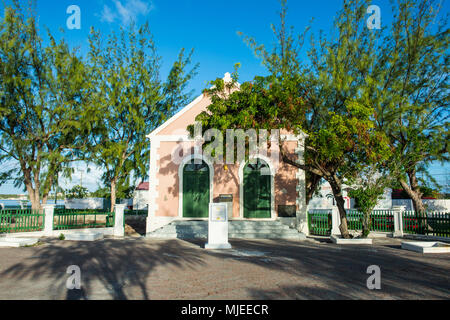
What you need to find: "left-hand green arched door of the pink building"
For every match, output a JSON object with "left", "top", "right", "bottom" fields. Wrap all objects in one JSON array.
[{"left": 183, "top": 160, "right": 210, "bottom": 218}]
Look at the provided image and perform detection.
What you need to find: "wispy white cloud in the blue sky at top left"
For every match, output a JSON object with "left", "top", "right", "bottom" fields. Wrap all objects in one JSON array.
[{"left": 101, "top": 0, "right": 153, "bottom": 25}]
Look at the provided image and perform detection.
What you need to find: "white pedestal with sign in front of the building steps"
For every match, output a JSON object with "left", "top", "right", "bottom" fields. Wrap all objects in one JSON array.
[{"left": 205, "top": 203, "right": 231, "bottom": 249}]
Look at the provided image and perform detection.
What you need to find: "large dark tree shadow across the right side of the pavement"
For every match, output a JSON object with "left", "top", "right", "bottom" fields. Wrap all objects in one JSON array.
[{"left": 207, "top": 240, "right": 450, "bottom": 300}]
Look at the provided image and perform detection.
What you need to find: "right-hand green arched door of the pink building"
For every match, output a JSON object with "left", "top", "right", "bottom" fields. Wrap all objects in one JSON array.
[{"left": 243, "top": 159, "right": 272, "bottom": 219}]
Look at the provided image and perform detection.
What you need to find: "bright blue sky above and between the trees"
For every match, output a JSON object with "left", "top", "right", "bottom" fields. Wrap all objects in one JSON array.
[{"left": 0, "top": 0, "right": 450, "bottom": 193}]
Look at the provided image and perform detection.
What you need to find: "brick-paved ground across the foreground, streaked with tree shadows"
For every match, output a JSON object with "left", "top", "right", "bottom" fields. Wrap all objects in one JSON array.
[{"left": 0, "top": 238, "right": 450, "bottom": 300}]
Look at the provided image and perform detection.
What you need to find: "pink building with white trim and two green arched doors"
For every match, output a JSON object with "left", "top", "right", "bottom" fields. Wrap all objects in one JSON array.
[{"left": 147, "top": 74, "right": 307, "bottom": 234}]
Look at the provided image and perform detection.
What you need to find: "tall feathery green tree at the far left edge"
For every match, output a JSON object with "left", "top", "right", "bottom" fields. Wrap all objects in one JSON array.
[{"left": 0, "top": 1, "right": 97, "bottom": 209}]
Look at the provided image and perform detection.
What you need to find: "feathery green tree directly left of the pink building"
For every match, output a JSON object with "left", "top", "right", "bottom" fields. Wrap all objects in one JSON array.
[{"left": 88, "top": 24, "right": 197, "bottom": 208}]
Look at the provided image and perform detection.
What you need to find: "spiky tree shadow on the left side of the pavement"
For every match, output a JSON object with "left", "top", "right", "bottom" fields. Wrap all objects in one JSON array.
[{"left": 0, "top": 239, "right": 204, "bottom": 300}]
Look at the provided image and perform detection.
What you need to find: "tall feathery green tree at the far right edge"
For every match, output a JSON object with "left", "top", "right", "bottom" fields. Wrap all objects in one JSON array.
[{"left": 371, "top": 0, "right": 450, "bottom": 211}]
